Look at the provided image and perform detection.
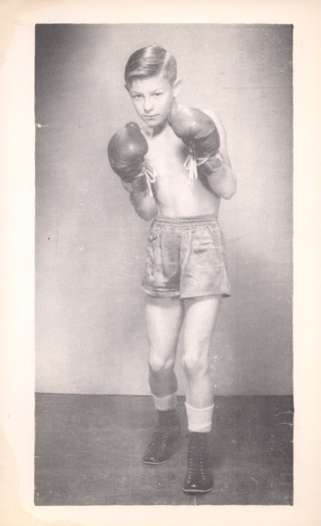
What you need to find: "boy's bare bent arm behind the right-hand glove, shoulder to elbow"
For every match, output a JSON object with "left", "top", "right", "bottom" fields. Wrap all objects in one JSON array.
[{"left": 204, "top": 110, "right": 237, "bottom": 199}]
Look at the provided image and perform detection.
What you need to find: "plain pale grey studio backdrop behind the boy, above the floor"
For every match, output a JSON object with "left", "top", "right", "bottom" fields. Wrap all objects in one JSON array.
[{"left": 36, "top": 24, "right": 292, "bottom": 394}]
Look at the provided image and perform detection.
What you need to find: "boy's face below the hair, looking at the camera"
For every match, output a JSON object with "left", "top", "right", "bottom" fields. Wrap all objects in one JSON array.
[{"left": 128, "top": 74, "right": 178, "bottom": 128}]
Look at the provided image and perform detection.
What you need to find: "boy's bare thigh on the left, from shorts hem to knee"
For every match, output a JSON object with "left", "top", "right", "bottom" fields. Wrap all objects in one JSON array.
[{"left": 145, "top": 296, "right": 184, "bottom": 355}]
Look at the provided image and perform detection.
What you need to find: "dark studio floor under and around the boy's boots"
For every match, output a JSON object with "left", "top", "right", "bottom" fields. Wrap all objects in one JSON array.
[{"left": 35, "top": 394, "right": 293, "bottom": 505}]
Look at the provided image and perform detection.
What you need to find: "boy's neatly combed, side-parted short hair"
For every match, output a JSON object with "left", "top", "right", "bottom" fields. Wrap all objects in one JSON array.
[{"left": 125, "top": 44, "right": 177, "bottom": 86}]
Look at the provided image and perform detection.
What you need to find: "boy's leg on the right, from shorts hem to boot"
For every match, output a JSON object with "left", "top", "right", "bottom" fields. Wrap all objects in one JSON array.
[{"left": 183, "top": 296, "right": 220, "bottom": 493}]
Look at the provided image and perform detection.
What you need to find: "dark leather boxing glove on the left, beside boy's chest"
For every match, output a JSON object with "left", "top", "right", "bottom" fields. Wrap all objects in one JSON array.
[{"left": 107, "top": 122, "right": 148, "bottom": 183}]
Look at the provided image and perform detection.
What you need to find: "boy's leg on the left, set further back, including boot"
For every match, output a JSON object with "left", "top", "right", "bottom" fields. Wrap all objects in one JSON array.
[{"left": 143, "top": 297, "right": 183, "bottom": 464}]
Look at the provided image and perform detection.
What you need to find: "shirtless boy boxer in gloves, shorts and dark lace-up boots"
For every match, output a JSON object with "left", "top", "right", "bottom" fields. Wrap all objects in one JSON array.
[{"left": 108, "top": 45, "right": 236, "bottom": 493}]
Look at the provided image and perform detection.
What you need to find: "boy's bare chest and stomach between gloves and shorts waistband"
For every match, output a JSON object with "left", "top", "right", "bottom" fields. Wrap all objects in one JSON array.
[{"left": 142, "top": 125, "right": 220, "bottom": 217}]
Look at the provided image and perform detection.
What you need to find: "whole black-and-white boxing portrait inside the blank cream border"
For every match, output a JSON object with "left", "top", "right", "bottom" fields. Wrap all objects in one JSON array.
[{"left": 34, "top": 23, "right": 294, "bottom": 506}]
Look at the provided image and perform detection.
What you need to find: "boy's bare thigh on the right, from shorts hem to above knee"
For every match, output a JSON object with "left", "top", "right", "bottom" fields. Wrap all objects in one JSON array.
[{"left": 183, "top": 295, "right": 221, "bottom": 346}]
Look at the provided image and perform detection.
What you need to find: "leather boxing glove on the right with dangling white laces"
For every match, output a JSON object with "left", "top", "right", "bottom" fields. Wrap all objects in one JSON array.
[{"left": 168, "top": 104, "right": 221, "bottom": 178}]
